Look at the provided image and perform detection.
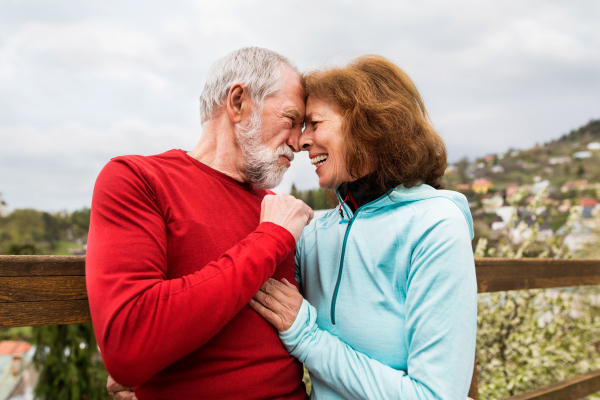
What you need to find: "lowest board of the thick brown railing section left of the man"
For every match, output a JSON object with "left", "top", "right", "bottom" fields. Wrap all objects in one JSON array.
[{"left": 0, "top": 300, "right": 92, "bottom": 328}]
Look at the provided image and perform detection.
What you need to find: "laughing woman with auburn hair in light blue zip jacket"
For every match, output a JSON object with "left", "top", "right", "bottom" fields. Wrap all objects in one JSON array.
[{"left": 251, "top": 56, "right": 477, "bottom": 400}]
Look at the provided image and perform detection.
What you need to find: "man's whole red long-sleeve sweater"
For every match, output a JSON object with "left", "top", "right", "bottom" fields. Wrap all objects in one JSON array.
[{"left": 86, "top": 150, "right": 305, "bottom": 400}]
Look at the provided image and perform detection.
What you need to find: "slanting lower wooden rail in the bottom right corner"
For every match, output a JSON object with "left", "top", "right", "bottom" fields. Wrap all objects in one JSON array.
[{"left": 504, "top": 369, "right": 600, "bottom": 400}]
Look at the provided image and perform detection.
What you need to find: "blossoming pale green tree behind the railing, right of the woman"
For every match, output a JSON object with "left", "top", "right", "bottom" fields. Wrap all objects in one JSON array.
[{"left": 475, "top": 191, "right": 600, "bottom": 399}]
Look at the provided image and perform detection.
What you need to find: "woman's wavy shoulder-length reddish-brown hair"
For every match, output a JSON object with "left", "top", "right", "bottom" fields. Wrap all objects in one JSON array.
[{"left": 302, "top": 55, "right": 447, "bottom": 191}]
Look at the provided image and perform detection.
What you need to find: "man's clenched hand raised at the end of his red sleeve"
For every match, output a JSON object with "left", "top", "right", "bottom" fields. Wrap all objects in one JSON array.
[{"left": 260, "top": 193, "right": 315, "bottom": 242}]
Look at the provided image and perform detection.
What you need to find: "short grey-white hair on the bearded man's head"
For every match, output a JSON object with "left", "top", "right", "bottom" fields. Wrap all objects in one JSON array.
[{"left": 200, "top": 47, "right": 299, "bottom": 125}]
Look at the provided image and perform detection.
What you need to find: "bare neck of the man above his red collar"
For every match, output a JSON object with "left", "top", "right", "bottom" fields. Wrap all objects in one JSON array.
[{"left": 188, "top": 117, "right": 248, "bottom": 182}]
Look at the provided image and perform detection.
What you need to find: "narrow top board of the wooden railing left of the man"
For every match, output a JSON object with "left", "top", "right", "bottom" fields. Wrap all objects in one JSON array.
[{"left": 0, "top": 256, "right": 85, "bottom": 276}]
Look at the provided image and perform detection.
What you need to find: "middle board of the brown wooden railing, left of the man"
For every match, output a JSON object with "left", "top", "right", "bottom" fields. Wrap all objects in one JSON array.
[{"left": 0, "top": 276, "right": 87, "bottom": 307}]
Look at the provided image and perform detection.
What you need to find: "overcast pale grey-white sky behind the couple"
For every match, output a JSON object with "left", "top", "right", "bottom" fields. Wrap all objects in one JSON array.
[{"left": 0, "top": 0, "right": 600, "bottom": 211}]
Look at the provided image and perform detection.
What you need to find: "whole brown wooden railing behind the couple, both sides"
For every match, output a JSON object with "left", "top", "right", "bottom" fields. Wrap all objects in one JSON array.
[{"left": 0, "top": 256, "right": 600, "bottom": 400}]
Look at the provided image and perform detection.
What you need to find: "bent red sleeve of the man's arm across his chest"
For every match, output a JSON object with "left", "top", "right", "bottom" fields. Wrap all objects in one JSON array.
[{"left": 86, "top": 159, "right": 295, "bottom": 386}]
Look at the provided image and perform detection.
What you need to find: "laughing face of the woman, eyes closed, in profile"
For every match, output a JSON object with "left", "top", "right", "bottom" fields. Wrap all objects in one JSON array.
[{"left": 300, "top": 96, "right": 354, "bottom": 189}]
